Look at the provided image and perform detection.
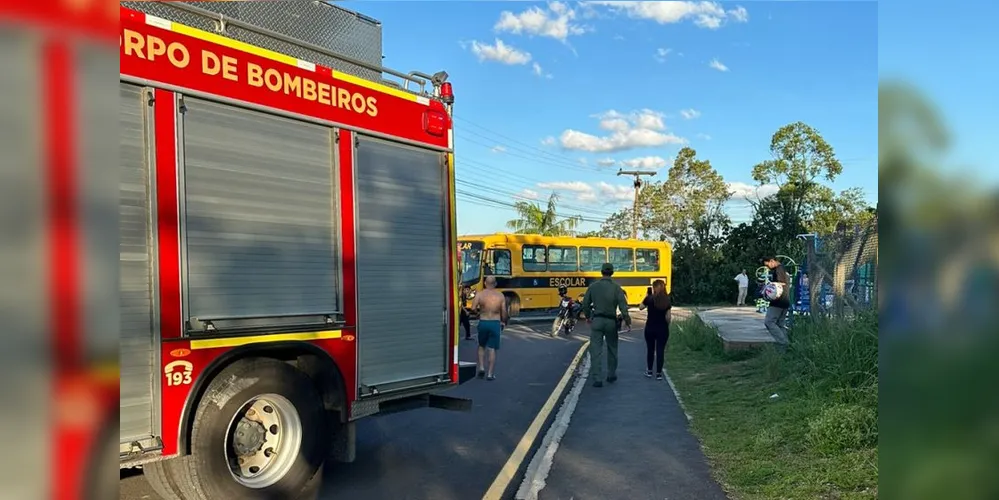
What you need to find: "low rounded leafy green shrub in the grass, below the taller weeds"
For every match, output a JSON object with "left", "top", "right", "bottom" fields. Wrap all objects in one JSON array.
[{"left": 807, "top": 403, "right": 878, "bottom": 453}]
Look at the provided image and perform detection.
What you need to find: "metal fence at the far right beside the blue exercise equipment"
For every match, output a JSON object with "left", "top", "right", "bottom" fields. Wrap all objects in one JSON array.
[{"left": 800, "top": 219, "right": 878, "bottom": 314}]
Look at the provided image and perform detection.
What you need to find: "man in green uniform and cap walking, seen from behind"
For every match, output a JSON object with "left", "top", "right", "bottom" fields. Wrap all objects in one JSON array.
[{"left": 583, "top": 262, "right": 631, "bottom": 387}]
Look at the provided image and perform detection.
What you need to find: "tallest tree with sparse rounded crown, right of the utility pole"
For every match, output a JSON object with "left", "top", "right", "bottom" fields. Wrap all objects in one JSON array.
[{"left": 753, "top": 122, "right": 843, "bottom": 228}]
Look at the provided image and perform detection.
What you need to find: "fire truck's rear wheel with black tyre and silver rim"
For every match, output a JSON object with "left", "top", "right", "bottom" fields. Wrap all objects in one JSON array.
[{"left": 190, "top": 358, "right": 330, "bottom": 500}]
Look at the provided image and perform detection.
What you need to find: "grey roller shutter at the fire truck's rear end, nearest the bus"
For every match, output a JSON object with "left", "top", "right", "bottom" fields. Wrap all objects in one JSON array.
[{"left": 355, "top": 136, "right": 448, "bottom": 392}]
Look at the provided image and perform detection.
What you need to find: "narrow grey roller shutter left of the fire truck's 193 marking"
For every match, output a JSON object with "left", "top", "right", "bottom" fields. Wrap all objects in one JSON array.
[{"left": 118, "top": 83, "right": 158, "bottom": 442}]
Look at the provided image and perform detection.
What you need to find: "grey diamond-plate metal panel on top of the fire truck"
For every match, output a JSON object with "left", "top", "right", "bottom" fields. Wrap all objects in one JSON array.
[{"left": 121, "top": 1, "right": 386, "bottom": 83}]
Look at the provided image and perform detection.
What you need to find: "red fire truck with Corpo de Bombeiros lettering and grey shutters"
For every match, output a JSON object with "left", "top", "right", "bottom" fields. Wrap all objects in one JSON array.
[{"left": 118, "top": 2, "right": 475, "bottom": 500}]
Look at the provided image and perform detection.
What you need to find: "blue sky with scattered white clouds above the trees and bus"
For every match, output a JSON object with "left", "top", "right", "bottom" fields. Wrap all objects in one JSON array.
[{"left": 345, "top": 1, "right": 878, "bottom": 234}]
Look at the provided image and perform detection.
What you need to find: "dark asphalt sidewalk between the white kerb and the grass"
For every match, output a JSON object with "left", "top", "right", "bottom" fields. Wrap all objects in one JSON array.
[{"left": 538, "top": 314, "right": 727, "bottom": 500}]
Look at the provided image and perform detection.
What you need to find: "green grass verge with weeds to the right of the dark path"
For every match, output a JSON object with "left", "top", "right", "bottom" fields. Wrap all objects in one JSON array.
[{"left": 667, "top": 315, "right": 878, "bottom": 500}]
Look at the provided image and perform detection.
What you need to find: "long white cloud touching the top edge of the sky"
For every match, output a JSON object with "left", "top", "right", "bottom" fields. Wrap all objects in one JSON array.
[{"left": 584, "top": 1, "right": 749, "bottom": 29}]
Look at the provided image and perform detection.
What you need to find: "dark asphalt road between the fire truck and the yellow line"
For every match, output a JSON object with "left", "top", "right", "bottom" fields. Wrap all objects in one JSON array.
[{"left": 119, "top": 323, "right": 585, "bottom": 500}]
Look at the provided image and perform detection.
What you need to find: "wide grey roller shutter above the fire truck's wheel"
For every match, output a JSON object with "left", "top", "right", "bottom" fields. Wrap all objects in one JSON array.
[{"left": 183, "top": 97, "right": 340, "bottom": 326}]
